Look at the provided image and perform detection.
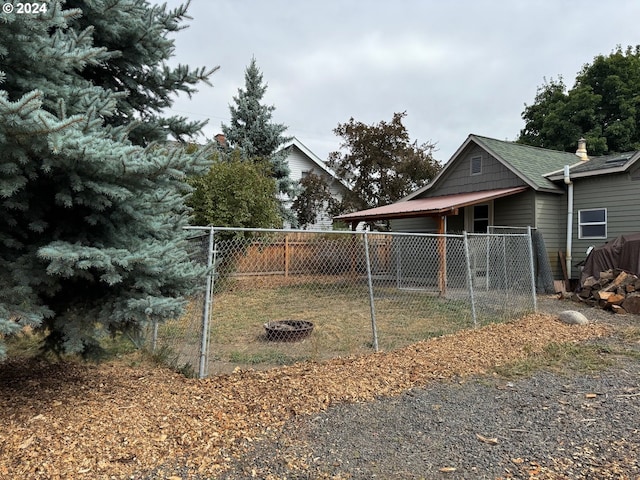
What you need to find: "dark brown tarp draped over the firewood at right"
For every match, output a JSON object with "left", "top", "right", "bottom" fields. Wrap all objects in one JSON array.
[{"left": 580, "top": 233, "right": 640, "bottom": 284}]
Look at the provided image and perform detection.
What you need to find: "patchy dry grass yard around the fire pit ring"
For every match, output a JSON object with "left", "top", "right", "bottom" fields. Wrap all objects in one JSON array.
[{"left": 165, "top": 282, "right": 484, "bottom": 374}]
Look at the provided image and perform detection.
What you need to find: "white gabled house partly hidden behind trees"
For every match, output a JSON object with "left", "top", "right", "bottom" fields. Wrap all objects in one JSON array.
[{"left": 282, "top": 137, "right": 348, "bottom": 230}]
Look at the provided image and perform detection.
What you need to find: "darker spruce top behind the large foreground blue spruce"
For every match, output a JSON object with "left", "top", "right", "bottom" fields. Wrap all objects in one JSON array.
[{"left": 65, "top": 0, "right": 218, "bottom": 146}]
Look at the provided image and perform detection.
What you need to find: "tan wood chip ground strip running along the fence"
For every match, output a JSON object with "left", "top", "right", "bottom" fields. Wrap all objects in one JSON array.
[{"left": 0, "top": 298, "right": 626, "bottom": 480}]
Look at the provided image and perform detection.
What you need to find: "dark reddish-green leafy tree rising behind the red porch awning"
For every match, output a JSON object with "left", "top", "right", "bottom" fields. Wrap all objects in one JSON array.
[{"left": 328, "top": 112, "right": 441, "bottom": 225}]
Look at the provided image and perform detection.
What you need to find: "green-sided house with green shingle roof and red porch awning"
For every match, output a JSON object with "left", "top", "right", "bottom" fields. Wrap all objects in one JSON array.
[{"left": 336, "top": 135, "right": 640, "bottom": 280}]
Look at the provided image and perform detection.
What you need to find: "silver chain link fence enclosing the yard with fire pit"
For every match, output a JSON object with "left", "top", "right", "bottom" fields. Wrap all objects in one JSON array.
[{"left": 145, "top": 227, "right": 536, "bottom": 377}]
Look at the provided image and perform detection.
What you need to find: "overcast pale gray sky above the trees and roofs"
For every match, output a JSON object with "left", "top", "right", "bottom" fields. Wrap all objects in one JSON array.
[{"left": 159, "top": 0, "right": 640, "bottom": 163}]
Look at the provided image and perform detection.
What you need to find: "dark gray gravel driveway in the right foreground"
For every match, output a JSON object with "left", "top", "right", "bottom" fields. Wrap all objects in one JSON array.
[{"left": 220, "top": 297, "right": 640, "bottom": 479}]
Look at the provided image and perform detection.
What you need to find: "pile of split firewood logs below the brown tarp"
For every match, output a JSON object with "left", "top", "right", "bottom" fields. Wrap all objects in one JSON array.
[{"left": 576, "top": 269, "right": 640, "bottom": 314}]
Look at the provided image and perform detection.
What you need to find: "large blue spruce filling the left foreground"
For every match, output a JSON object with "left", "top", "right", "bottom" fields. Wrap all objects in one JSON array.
[{"left": 0, "top": 0, "right": 215, "bottom": 355}]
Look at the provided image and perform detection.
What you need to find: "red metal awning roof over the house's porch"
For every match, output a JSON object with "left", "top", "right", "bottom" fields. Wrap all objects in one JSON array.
[{"left": 334, "top": 187, "right": 529, "bottom": 223}]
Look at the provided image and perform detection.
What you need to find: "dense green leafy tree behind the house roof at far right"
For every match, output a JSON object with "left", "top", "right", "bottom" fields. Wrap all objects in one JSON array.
[{"left": 518, "top": 46, "right": 640, "bottom": 155}]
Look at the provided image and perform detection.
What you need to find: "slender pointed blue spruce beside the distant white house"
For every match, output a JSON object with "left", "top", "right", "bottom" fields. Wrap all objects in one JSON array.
[{"left": 222, "top": 58, "right": 296, "bottom": 224}]
